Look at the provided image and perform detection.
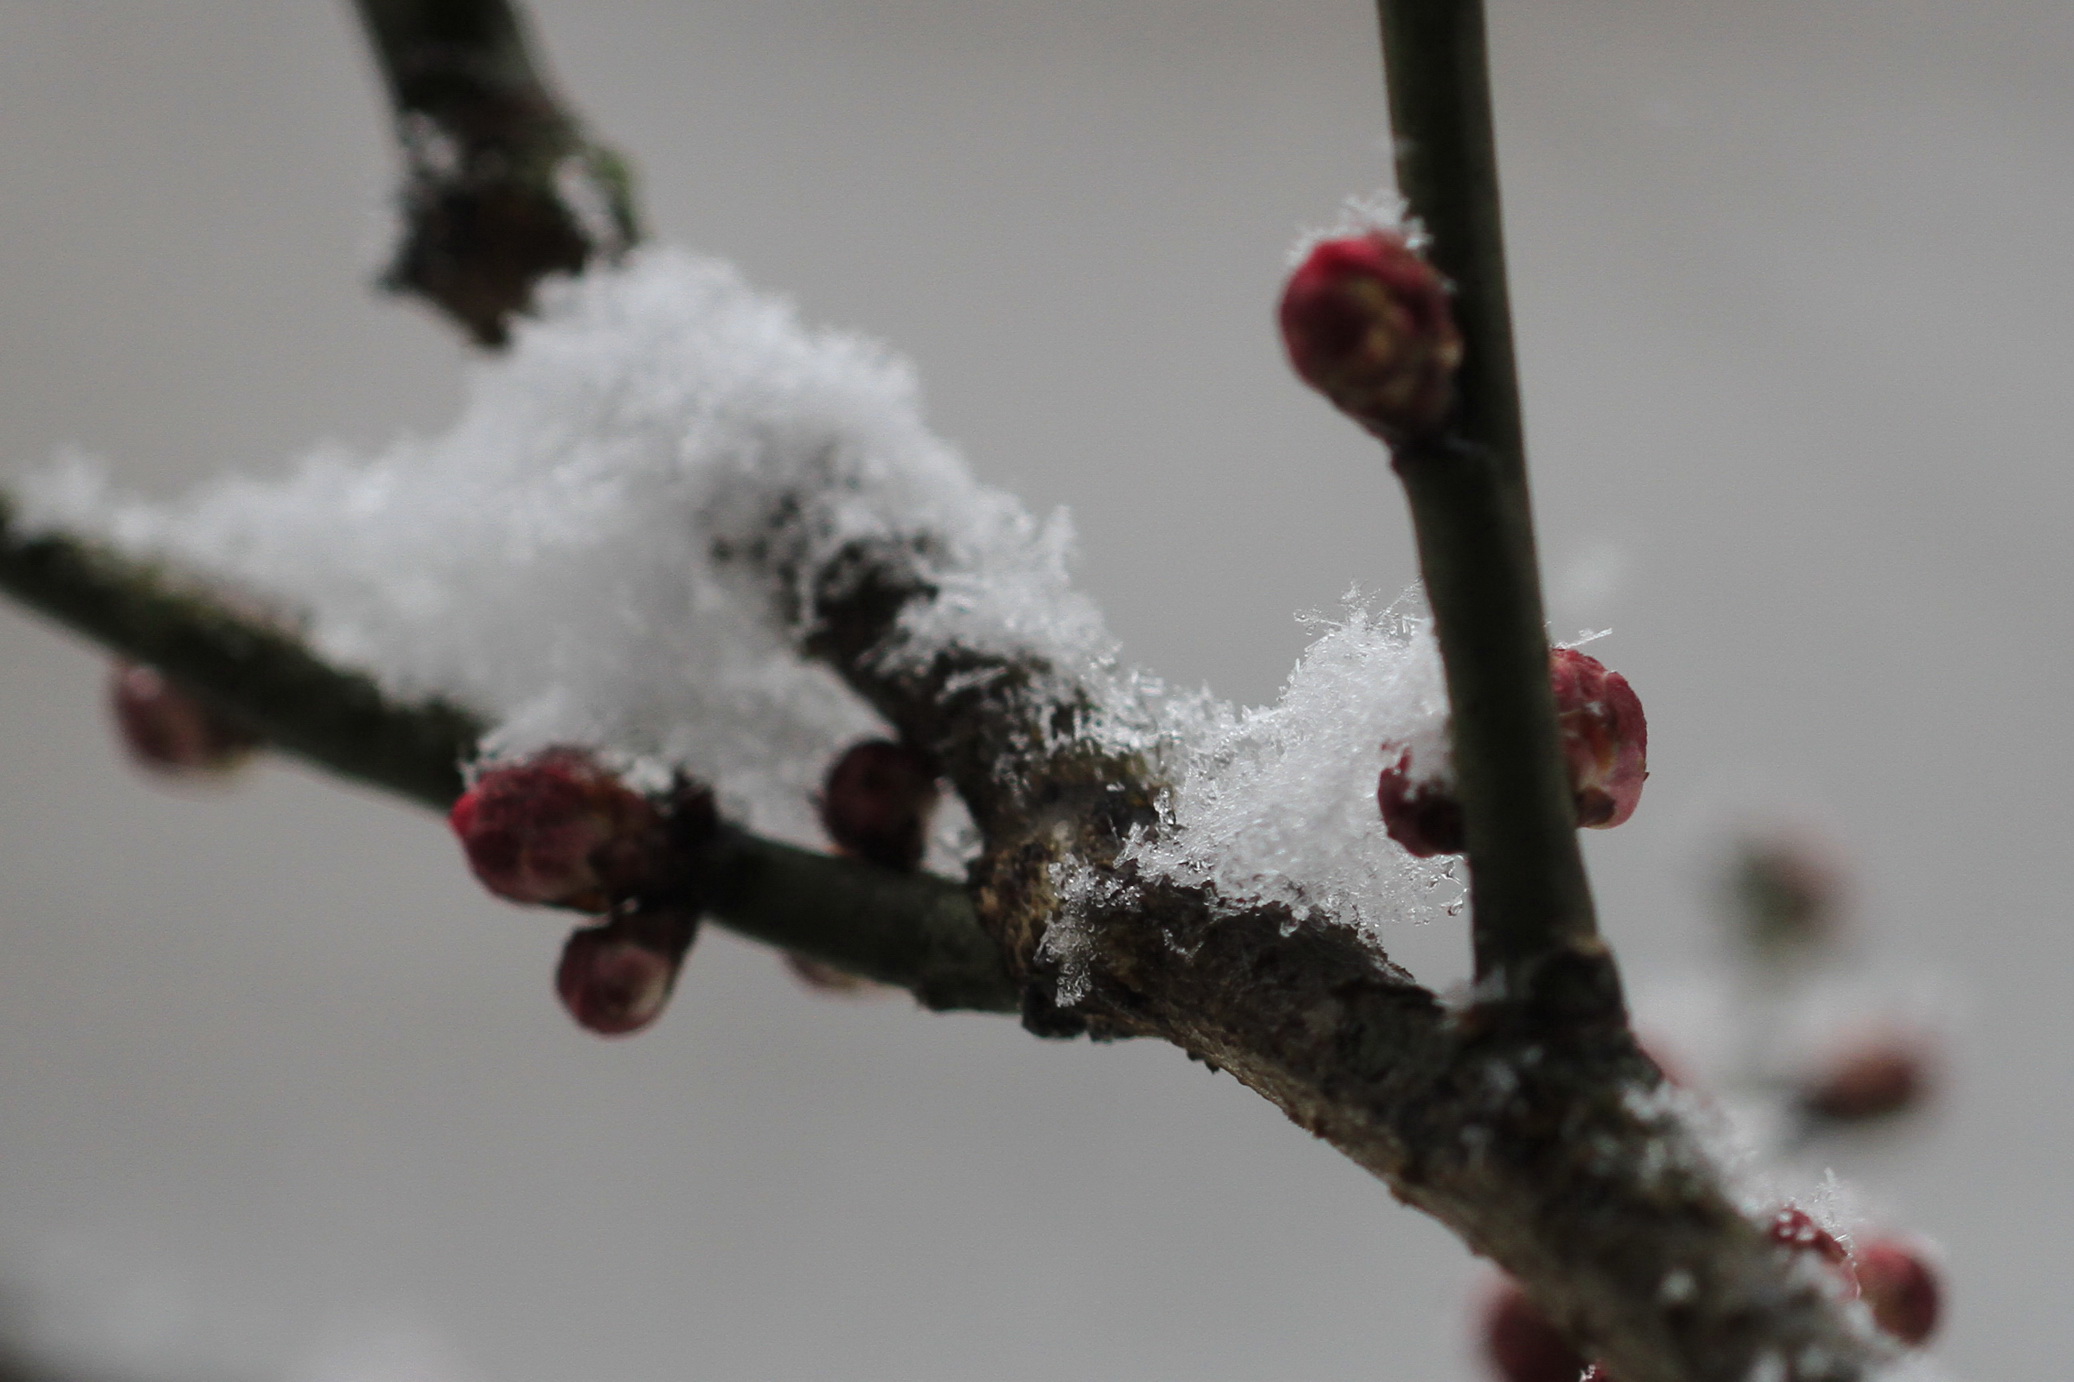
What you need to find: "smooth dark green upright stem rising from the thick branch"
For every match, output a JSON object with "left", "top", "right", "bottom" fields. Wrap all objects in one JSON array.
[{"left": 1379, "top": 0, "right": 1618, "bottom": 991}]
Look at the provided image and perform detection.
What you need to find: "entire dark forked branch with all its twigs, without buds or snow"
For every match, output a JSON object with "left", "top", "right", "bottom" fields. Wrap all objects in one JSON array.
[{"left": 0, "top": 0, "right": 1887, "bottom": 1382}]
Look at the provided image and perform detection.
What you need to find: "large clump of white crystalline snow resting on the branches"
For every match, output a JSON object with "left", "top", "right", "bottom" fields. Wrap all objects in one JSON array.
[{"left": 25, "top": 249, "right": 1458, "bottom": 925}]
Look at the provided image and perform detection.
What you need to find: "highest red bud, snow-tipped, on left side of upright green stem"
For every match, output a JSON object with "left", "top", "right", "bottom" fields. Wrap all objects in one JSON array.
[{"left": 1280, "top": 230, "right": 1462, "bottom": 440}]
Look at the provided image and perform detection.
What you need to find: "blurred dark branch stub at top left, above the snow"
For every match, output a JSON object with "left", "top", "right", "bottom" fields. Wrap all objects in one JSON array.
[{"left": 355, "top": 0, "right": 641, "bottom": 347}]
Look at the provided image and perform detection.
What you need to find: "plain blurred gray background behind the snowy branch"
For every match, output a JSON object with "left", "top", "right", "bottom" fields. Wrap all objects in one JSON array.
[{"left": 0, "top": 0, "right": 2074, "bottom": 1382}]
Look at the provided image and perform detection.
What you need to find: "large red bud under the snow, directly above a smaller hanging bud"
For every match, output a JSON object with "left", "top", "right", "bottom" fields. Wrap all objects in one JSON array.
[{"left": 448, "top": 749, "right": 666, "bottom": 911}]
